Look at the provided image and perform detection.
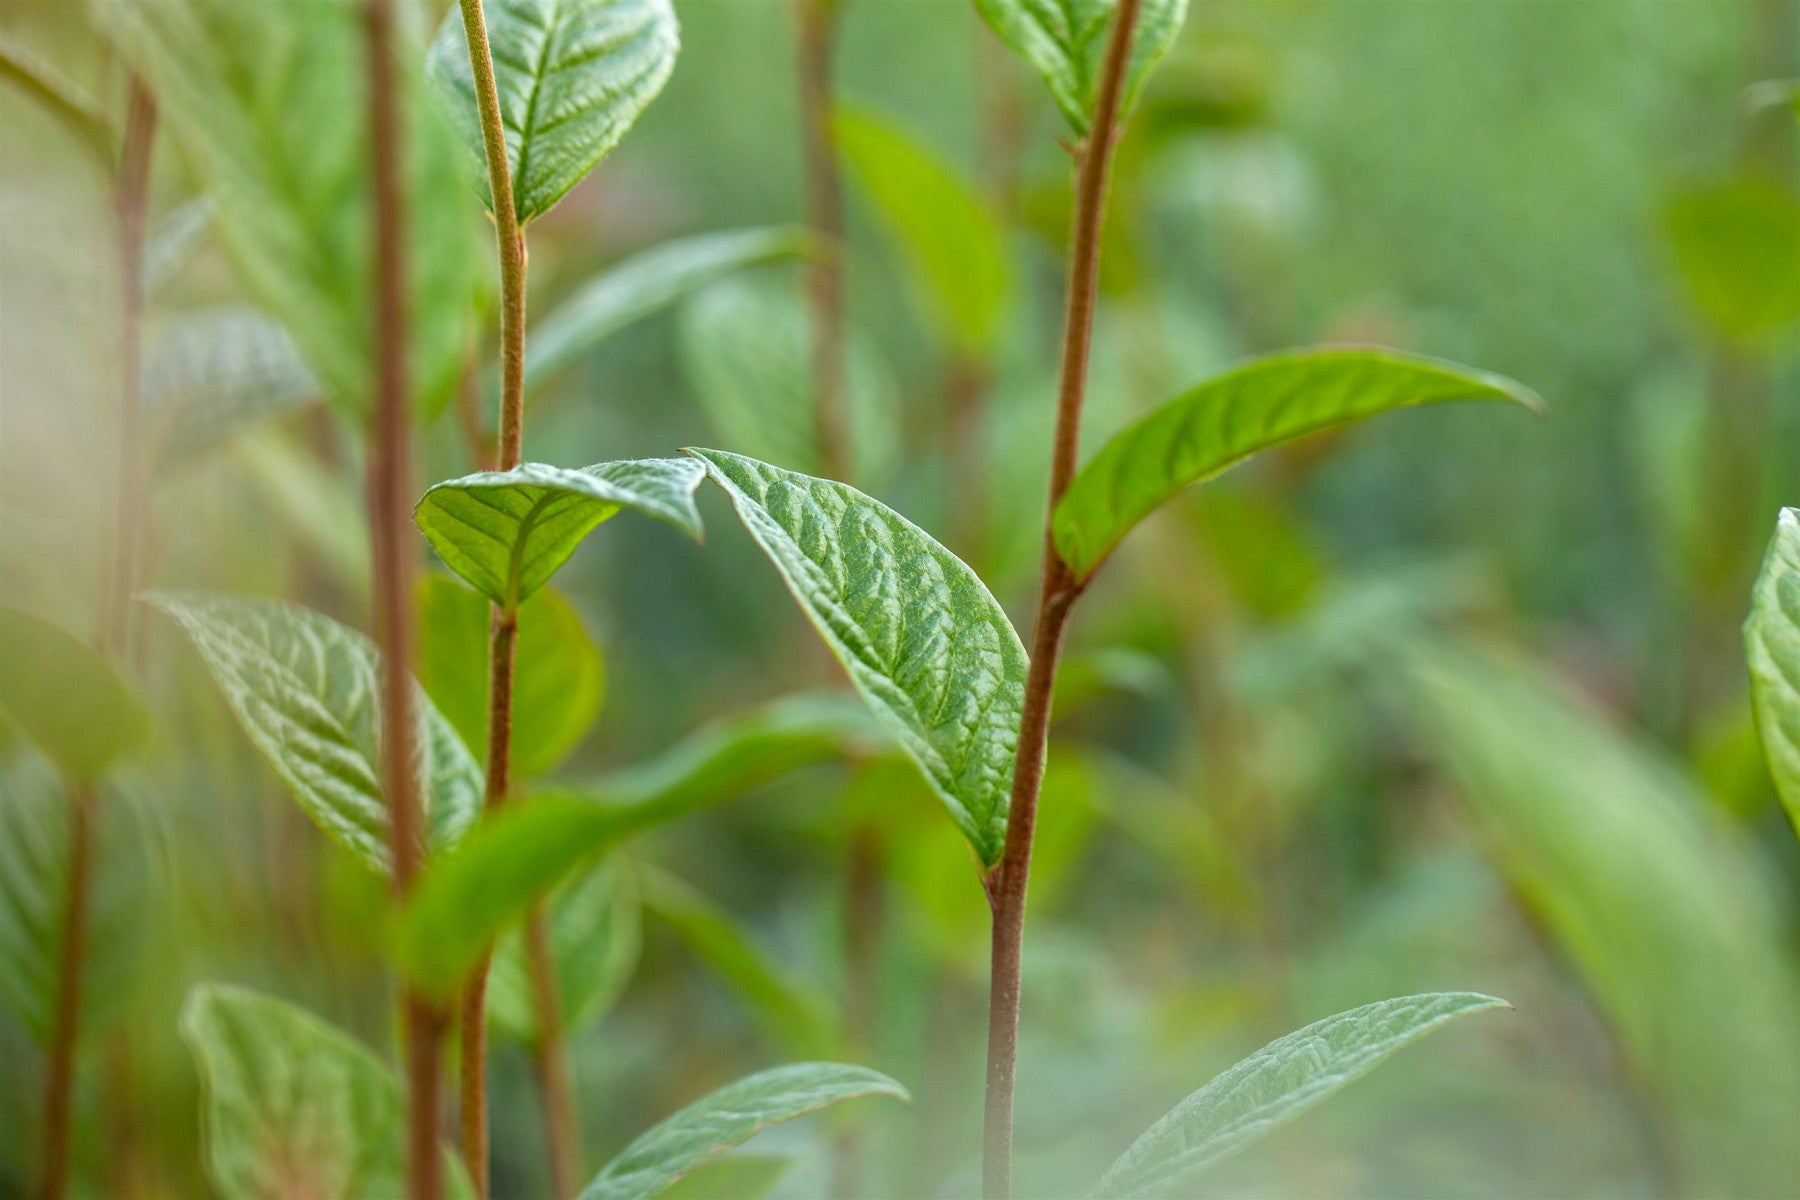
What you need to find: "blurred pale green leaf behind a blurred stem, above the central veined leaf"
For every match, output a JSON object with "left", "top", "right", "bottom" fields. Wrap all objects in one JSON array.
[{"left": 680, "top": 279, "right": 900, "bottom": 480}]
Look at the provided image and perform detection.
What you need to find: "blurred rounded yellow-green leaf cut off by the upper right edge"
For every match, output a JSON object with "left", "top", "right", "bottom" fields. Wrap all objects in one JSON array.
[{"left": 1663, "top": 178, "right": 1800, "bottom": 340}]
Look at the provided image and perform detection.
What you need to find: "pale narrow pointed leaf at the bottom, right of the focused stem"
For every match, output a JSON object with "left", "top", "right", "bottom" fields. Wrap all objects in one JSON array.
[{"left": 1094, "top": 991, "right": 1507, "bottom": 1196}]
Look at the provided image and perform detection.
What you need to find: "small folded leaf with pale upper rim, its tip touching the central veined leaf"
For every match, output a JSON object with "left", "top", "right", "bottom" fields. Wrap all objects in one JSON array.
[{"left": 412, "top": 459, "right": 702, "bottom": 608}]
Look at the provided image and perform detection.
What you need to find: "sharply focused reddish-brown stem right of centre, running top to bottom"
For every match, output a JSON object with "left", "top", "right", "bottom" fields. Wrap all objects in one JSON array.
[{"left": 981, "top": 0, "right": 1139, "bottom": 1200}]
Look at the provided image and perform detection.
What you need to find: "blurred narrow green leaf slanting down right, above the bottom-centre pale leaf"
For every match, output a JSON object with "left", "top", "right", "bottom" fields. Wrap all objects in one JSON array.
[{"left": 641, "top": 867, "right": 837, "bottom": 1054}]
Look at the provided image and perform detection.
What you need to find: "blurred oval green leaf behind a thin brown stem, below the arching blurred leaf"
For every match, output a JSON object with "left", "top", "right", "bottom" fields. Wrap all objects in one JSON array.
[{"left": 488, "top": 862, "right": 643, "bottom": 1045}]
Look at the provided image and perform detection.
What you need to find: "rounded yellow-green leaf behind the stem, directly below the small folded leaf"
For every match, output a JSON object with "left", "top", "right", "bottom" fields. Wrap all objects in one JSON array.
[{"left": 418, "top": 574, "right": 607, "bottom": 779}]
